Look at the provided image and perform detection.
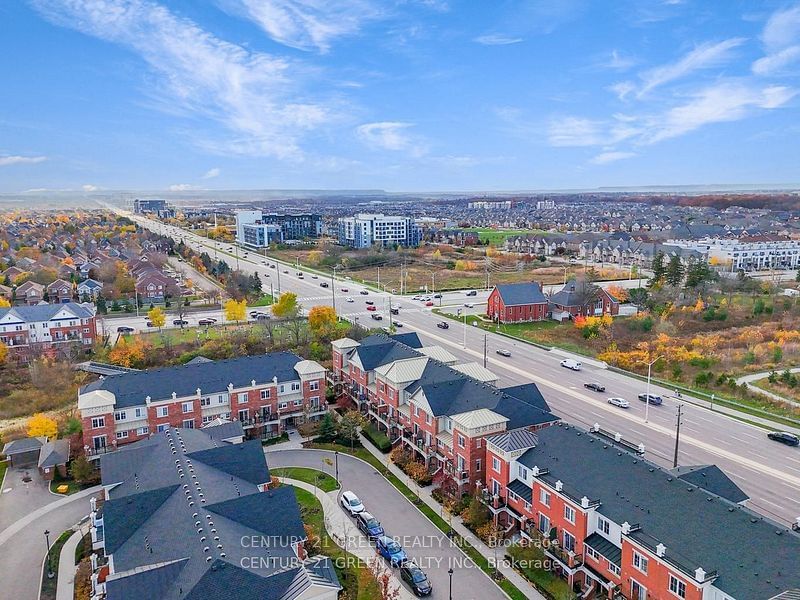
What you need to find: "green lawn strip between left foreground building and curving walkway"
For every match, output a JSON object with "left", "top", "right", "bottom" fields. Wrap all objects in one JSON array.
[{"left": 294, "top": 488, "right": 381, "bottom": 600}]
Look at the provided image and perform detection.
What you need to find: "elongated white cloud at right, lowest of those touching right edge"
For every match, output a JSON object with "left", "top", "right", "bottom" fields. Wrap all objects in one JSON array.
[{"left": 643, "top": 82, "right": 797, "bottom": 143}]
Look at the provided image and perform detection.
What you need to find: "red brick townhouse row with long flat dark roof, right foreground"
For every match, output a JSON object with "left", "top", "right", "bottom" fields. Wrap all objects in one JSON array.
[{"left": 485, "top": 424, "right": 800, "bottom": 600}]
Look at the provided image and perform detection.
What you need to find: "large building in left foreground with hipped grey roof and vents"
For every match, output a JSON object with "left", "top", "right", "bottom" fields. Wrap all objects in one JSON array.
[{"left": 89, "top": 423, "right": 341, "bottom": 600}]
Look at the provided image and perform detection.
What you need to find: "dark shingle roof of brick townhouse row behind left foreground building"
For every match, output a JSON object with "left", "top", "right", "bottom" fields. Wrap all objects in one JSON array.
[{"left": 81, "top": 352, "right": 302, "bottom": 409}]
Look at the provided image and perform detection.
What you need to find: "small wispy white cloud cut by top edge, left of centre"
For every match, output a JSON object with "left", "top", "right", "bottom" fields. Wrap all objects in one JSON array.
[{"left": 228, "top": 0, "right": 383, "bottom": 52}]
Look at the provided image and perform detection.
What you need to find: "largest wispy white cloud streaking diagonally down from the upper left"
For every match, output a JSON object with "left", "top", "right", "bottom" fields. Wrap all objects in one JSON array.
[{"left": 32, "top": 0, "right": 332, "bottom": 159}]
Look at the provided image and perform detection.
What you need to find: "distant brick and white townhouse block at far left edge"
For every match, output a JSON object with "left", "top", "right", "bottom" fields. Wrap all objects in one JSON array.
[{"left": 0, "top": 302, "right": 97, "bottom": 357}]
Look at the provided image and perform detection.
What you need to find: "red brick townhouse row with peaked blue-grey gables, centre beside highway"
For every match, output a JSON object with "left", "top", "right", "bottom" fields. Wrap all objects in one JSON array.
[{"left": 333, "top": 333, "right": 558, "bottom": 495}]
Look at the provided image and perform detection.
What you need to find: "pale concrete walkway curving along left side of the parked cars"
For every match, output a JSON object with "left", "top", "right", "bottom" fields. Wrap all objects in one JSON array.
[{"left": 276, "top": 477, "right": 416, "bottom": 600}]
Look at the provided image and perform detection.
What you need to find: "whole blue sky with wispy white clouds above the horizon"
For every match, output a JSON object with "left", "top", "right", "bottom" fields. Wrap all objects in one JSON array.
[{"left": 0, "top": 0, "right": 800, "bottom": 192}]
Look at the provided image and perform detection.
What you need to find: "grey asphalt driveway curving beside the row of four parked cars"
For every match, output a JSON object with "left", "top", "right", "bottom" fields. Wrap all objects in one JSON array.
[{"left": 267, "top": 448, "right": 505, "bottom": 600}]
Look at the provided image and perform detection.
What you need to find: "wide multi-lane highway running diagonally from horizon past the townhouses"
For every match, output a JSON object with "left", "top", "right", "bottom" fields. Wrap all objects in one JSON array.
[{"left": 127, "top": 215, "right": 800, "bottom": 523}]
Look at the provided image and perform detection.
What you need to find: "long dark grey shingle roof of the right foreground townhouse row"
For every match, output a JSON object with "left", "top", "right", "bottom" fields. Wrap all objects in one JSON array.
[{"left": 518, "top": 426, "right": 800, "bottom": 598}]
